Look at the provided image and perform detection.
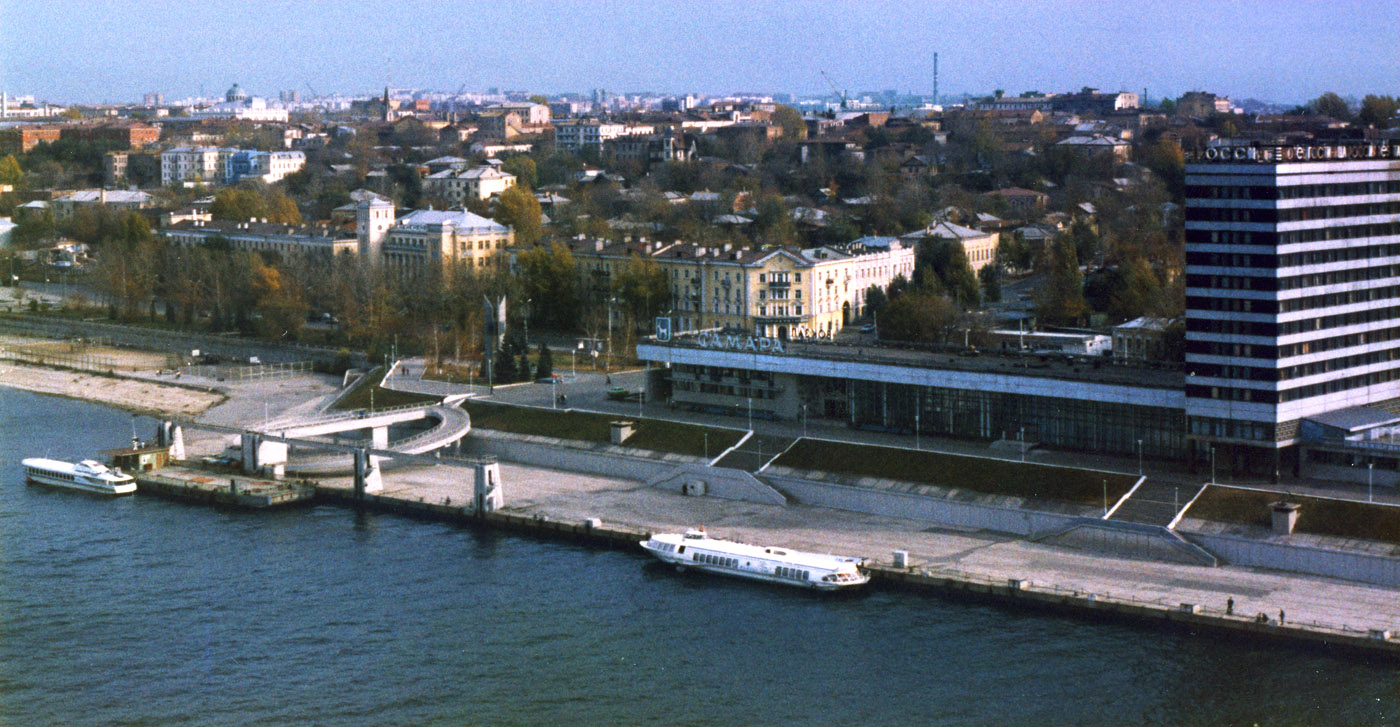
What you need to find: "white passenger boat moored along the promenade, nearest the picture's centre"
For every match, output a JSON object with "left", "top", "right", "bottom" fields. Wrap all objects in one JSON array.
[{"left": 641, "top": 529, "right": 869, "bottom": 591}]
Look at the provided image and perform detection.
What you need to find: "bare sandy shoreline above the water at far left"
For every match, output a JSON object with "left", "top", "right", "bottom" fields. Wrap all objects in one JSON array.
[{"left": 0, "top": 361, "right": 227, "bottom": 416}]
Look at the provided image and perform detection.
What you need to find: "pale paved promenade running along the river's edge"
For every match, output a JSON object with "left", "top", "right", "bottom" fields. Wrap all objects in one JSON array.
[{"left": 326, "top": 464, "right": 1400, "bottom": 644}]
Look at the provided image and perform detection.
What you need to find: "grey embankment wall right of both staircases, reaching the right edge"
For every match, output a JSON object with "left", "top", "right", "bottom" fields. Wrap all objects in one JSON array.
[{"left": 1177, "top": 531, "right": 1400, "bottom": 588}]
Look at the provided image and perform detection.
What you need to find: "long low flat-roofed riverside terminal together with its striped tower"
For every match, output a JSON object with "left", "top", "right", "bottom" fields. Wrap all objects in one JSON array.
[{"left": 637, "top": 143, "right": 1400, "bottom": 483}]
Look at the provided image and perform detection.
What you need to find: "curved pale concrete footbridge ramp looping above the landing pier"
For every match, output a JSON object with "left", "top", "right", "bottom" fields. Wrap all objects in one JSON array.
[{"left": 245, "top": 395, "right": 472, "bottom": 475}]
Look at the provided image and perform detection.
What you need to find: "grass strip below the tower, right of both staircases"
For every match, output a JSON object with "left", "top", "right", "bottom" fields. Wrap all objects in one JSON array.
[{"left": 1186, "top": 485, "right": 1400, "bottom": 542}]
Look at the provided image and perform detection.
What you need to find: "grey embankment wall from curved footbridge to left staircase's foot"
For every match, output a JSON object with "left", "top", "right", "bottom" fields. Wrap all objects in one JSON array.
[{"left": 462, "top": 430, "right": 787, "bottom": 504}]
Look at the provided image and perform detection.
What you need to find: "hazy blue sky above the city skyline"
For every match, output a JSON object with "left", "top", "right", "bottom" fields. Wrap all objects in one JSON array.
[{"left": 0, "top": 0, "right": 1400, "bottom": 102}]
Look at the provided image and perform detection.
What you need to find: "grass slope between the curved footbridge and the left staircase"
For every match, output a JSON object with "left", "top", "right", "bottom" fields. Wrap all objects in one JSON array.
[{"left": 462, "top": 399, "right": 743, "bottom": 457}]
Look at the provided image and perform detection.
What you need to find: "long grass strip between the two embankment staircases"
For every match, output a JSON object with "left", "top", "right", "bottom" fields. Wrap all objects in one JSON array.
[{"left": 773, "top": 440, "right": 1138, "bottom": 506}]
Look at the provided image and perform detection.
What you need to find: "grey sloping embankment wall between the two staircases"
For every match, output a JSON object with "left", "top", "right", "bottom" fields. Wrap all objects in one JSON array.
[{"left": 760, "top": 475, "right": 1081, "bottom": 535}]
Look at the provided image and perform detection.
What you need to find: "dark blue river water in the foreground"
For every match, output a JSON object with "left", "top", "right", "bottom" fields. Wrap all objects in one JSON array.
[{"left": 0, "top": 388, "right": 1400, "bottom": 726}]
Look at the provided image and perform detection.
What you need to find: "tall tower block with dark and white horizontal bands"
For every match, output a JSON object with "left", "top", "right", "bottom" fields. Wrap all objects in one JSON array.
[{"left": 1186, "top": 141, "right": 1400, "bottom": 473}]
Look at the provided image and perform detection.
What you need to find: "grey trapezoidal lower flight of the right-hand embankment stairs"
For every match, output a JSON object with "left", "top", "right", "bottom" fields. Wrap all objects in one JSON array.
[{"left": 1029, "top": 517, "right": 1221, "bottom": 567}]
